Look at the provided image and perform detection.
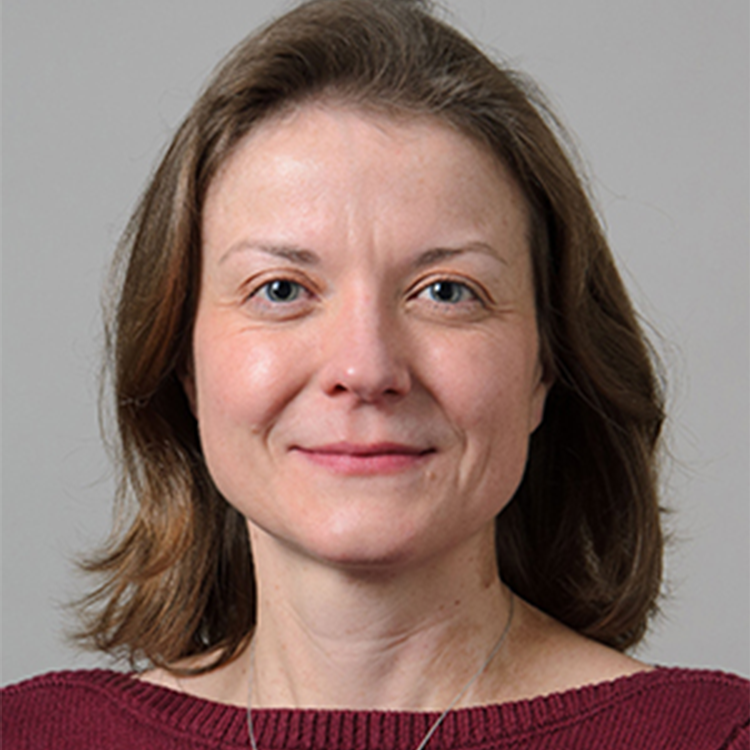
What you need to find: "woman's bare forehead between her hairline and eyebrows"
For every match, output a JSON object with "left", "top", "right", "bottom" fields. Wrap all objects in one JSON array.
[{"left": 203, "top": 101, "right": 528, "bottom": 253}]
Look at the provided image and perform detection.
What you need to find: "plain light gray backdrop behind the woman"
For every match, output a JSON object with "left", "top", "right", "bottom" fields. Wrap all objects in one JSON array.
[{"left": 2, "top": 0, "right": 750, "bottom": 682}]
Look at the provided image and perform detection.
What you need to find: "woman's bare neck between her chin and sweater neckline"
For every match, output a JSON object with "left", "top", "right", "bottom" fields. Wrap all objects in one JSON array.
[{"left": 251, "top": 527, "right": 510, "bottom": 711}]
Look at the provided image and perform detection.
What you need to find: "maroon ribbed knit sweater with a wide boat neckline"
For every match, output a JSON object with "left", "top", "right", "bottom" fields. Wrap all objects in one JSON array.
[{"left": 1, "top": 669, "right": 750, "bottom": 750}]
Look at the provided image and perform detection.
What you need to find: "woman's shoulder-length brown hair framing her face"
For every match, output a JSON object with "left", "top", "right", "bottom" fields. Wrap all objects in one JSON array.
[{"left": 75, "top": 0, "right": 663, "bottom": 669}]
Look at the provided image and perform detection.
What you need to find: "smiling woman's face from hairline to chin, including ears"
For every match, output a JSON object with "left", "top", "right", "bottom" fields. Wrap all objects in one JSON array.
[{"left": 191, "top": 104, "right": 546, "bottom": 566}]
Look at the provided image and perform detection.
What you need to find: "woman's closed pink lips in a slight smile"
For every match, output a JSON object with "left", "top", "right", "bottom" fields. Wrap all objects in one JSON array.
[{"left": 294, "top": 442, "right": 435, "bottom": 476}]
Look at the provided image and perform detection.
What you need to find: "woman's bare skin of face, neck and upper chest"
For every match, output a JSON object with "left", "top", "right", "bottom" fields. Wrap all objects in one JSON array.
[{"left": 146, "top": 102, "right": 643, "bottom": 710}]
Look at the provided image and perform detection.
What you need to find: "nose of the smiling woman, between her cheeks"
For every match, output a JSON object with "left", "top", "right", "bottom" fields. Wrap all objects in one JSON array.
[{"left": 320, "top": 298, "right": 412, "bottom": 403}]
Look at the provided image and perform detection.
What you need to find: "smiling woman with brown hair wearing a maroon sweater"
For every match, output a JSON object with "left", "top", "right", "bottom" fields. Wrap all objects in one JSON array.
[{"left": 4, "top": 0, "right": 750, "bottom": 748}]
